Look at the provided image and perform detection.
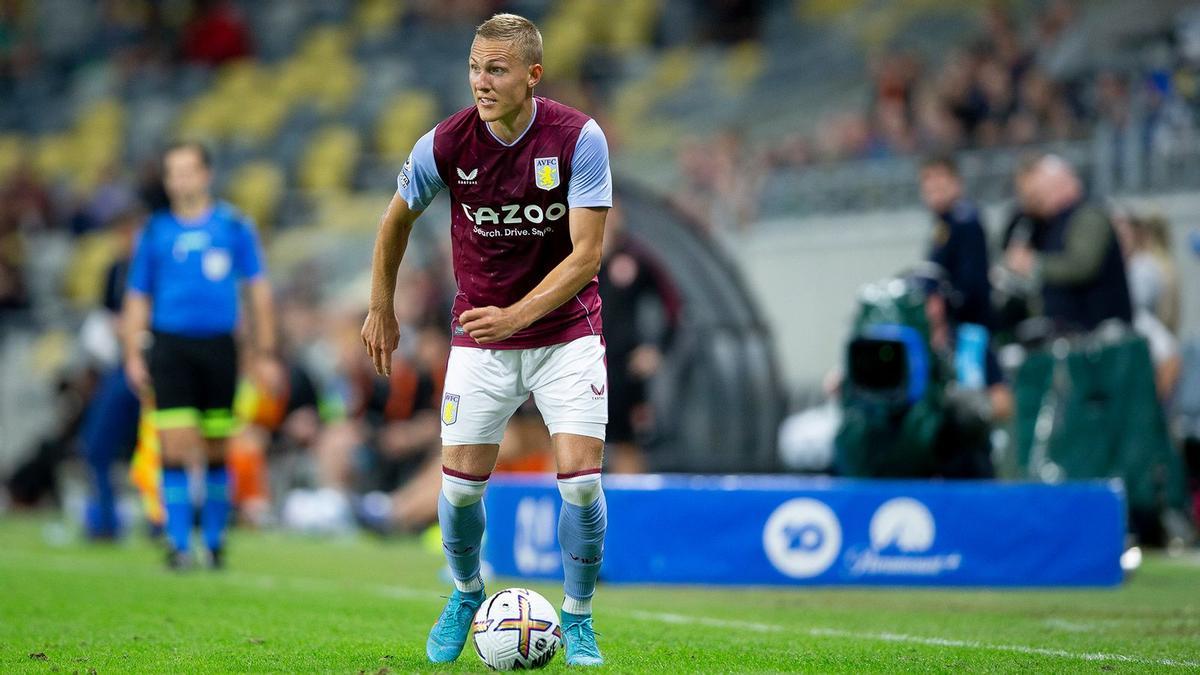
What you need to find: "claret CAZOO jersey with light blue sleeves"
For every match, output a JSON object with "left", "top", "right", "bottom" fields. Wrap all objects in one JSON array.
[{"left": 397, "top": 96, "right": 612, "bottom": 350}]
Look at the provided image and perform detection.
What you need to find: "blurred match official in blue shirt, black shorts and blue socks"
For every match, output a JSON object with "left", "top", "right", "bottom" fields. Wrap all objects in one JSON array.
[{"left": 122, "top": 143, "right": 282, "bottom": 569}]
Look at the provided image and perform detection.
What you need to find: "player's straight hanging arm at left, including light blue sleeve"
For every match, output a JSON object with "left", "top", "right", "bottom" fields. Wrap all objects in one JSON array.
[{"left": 362, "top": 129, "right": 445, "bottom": 376}]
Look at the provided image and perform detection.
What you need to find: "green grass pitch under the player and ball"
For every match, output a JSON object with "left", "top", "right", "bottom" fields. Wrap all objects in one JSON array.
[{"left": 0, "top": 516, "right": 1200, "bottom": 674}]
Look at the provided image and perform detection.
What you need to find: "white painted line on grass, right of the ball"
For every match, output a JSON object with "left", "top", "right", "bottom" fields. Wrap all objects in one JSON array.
[{"left": 625, "top": 611, "right": 1200, "bottom": 668}]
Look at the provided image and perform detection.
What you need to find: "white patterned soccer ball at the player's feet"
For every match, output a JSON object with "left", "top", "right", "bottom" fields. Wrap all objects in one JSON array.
[{"left": 470, "top": 589, "right": 563, "bottom": 670}]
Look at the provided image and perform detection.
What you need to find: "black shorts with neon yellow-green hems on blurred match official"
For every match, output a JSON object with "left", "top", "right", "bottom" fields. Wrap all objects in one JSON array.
[{"left": 148, "top": 330, "right": 238, "bottom": 438}]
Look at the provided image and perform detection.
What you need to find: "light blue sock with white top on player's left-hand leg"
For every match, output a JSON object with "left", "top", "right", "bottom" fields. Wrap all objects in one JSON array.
[{"left": 438, "top": 467, "right": 488, "bottom": 593}]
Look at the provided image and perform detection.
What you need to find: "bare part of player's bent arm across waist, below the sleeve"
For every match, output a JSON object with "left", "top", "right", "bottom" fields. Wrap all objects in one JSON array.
[{"left": 458, "top": 207, "right": 608, "bottom": 345}]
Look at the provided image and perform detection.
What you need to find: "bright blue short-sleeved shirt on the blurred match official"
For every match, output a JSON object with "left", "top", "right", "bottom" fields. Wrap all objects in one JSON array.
[{"left": 128, "top": 203, "right": 264, "bottom": 338}]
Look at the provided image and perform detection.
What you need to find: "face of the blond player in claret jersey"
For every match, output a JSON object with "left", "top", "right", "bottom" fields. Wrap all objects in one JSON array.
[{"left": 469, "top": 38, "right": 541, "bottom": 121}]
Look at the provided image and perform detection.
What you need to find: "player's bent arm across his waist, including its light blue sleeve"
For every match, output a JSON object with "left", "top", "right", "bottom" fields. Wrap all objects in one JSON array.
[{"left": 458, "top": 120, "right": 612, "bottom": 345}]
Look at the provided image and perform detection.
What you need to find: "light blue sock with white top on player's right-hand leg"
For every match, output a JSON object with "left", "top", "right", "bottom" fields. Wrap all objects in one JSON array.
[{"left": 558, "top": 470, "right": 608, "bottom": 616}]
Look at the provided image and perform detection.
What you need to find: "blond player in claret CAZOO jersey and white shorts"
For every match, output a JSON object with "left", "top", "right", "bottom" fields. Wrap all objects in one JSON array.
[{"left": 362, "top": 14, "right": 612, "bottom": 665}]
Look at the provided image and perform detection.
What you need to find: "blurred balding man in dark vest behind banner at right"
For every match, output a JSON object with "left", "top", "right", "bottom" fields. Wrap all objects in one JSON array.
[{"left": 1006, "top": 155, "right": 1133, "bottom": 330}]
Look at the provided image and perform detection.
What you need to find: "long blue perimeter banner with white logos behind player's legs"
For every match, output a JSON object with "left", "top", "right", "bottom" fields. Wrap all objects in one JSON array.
[{"left": 485, "top": 474, "right": 1126, "bottom": 586}]
